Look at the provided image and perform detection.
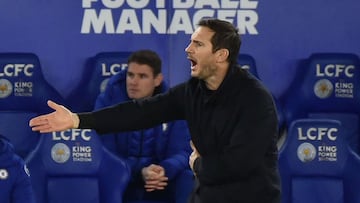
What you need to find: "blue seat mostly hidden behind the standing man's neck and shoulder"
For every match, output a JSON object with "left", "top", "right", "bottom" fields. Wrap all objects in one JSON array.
[{"left": 238, "top": 54, "right": 284, "bottom": 133}]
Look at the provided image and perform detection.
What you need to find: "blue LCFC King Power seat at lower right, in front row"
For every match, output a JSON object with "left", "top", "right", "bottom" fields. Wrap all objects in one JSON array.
[{"left": 279, "top": 119, "right": 360, "bottom": 203}]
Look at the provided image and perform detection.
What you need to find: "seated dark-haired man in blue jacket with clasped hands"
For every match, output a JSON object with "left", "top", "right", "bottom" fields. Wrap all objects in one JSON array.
[{"left": 95, "top": 50, "right": 193, "bottom": 203}]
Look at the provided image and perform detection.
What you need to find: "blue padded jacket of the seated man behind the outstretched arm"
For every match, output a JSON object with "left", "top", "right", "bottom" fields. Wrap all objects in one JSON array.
[{"left": 95, "top": 70, "right": 191, "bottom": 181}]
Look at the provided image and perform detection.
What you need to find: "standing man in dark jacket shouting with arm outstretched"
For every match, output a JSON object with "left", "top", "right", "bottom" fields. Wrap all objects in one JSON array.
[{"left": 29, "top": 19, "right": 280, "bottom": 203}]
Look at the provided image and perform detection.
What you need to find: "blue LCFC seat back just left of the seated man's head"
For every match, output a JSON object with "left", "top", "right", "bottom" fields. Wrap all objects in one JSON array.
[{"left": 65, "top": 52, "right": 131, "bottom": 112}]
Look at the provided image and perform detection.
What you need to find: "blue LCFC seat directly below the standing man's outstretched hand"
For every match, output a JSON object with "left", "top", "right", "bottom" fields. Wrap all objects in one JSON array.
[{"left": 26, "top": 129, "right": 130, "bottom": 203}]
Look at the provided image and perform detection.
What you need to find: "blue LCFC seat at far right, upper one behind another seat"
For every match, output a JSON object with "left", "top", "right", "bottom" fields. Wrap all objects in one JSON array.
[{"left": 281, "top": 53, "right": 360, "bottom": 152}]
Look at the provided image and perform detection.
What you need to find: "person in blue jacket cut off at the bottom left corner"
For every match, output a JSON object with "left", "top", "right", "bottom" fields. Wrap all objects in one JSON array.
[{"left": 0, "top": 135, "right": 35, "bottom": 203}]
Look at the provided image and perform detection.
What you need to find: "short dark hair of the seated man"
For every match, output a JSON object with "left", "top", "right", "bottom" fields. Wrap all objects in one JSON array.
[{"left": 127, "top": 49, "right": 161, "bottom": 76}]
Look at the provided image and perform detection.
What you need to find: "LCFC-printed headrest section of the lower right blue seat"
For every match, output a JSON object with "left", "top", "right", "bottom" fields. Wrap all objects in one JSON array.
[{"left": 279, "top": 119, "right": 350, "bottom": 175}]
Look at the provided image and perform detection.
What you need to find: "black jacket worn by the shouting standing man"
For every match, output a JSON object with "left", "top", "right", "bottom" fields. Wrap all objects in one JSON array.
[{"left": 78, "top": 66, "right": 280, "bottom": 203}]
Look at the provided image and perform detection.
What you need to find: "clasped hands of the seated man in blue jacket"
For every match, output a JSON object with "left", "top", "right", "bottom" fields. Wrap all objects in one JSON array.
[{"left": 141, "top": 164, "right": 168, "bottom": 192}]
